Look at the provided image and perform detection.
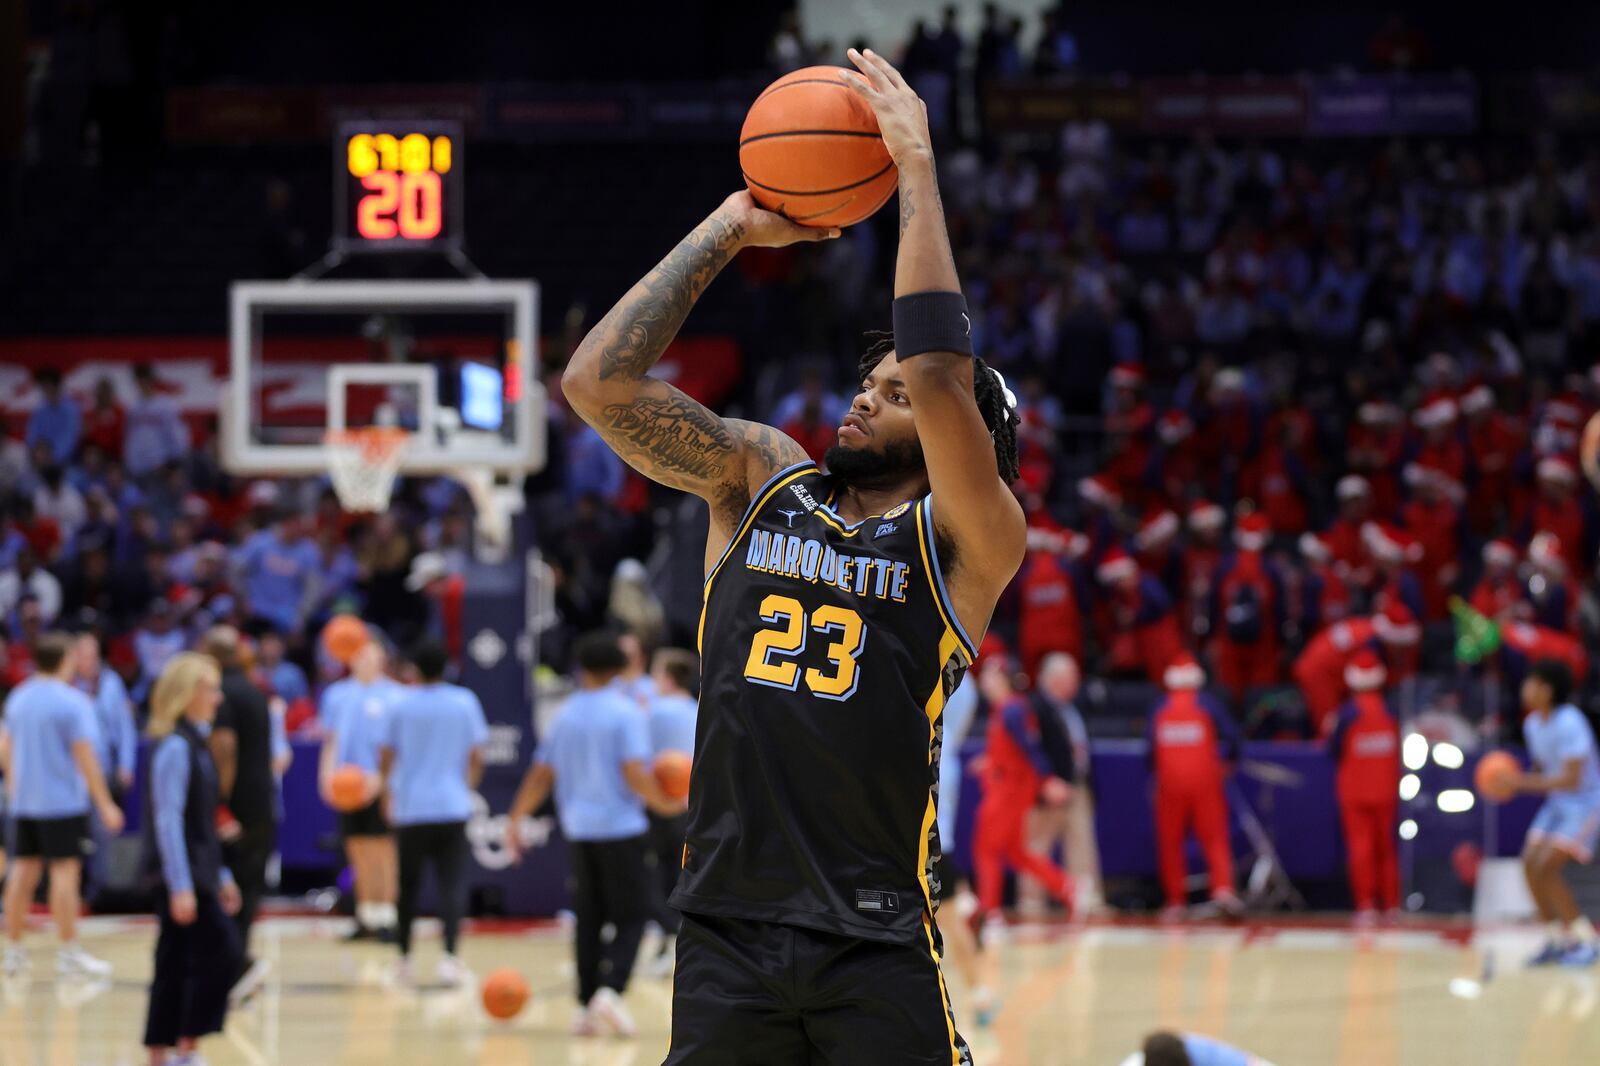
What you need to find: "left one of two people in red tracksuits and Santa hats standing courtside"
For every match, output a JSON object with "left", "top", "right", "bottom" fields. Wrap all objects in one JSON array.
[{"left": 1149, "top": 651, "right": 1243, "bottom": 919}]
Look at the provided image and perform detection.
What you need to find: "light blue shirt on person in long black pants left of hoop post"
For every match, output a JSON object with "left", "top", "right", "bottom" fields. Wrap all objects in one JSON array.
[{"left": 382, "top": 682, "right": 490, "bottom": 826}]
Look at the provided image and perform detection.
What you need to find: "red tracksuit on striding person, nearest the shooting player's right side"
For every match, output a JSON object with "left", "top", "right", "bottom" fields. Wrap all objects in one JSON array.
[{"left": 973, "top": 696, "right": 1072, "bottom": 912}]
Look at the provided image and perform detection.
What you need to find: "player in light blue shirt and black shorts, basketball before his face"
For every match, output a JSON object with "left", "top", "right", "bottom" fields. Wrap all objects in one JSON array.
[{"left": 318, "top": 640, "right": 406, "bottom": 940}]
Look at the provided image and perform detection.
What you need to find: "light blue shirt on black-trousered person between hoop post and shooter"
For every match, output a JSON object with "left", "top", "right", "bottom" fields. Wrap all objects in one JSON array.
[{"left": 533, "top": 687, "right": 653, "bottom": 840}]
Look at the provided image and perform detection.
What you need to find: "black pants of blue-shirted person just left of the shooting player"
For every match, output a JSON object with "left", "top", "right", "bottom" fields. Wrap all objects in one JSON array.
[{"left": 568, "top": 836, "right": 653, "bottom": 1004}]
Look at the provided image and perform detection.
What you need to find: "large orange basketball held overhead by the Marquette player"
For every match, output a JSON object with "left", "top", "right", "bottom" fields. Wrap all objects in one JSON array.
[{"left": 739, "top": 67, "right": 899, "bottom": 229}]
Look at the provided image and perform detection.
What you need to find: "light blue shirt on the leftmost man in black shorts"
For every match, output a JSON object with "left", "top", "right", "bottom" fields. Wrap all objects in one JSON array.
[{"left": 5, "top": 677, "right": 101, "bottom": 818}]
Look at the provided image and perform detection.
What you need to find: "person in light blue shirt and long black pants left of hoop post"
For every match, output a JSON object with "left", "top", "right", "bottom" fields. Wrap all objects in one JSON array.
[{"left": 379, "top": 640, "right": 490, "bottom": 986}]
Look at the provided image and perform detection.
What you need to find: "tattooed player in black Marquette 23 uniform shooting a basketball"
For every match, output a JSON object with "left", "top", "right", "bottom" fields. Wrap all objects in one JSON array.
[{"left": 563, "top": 51, "right": 1027, "bottom": 1066}]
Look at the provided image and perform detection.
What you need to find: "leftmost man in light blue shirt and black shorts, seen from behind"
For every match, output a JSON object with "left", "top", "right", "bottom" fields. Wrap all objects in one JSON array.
[{"left": 0, "top": 632, "right": 122, "bottom": 976}]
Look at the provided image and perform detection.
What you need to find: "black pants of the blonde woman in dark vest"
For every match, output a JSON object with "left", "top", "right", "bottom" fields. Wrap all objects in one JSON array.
[{"left": 144, "top": 890, "right": 242, "bottom": 1047}]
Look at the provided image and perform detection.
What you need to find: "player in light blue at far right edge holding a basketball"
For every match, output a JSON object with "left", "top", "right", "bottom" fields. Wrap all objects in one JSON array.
[{"left": 1515, "top": 659, "right": 1600, "bottom": 967}]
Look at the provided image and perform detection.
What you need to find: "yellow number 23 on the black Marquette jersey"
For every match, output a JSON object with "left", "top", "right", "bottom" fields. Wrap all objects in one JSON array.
[{"left": 744, "top": 594, "right": 867, "bottom": 699}]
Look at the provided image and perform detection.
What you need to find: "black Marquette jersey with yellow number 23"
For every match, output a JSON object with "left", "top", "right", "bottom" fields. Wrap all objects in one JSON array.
[{"left": 672, "top": 463, "right": 974, "bottom": 943}]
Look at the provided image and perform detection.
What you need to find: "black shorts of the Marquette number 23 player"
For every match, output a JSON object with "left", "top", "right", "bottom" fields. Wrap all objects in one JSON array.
[{"left": 666, "top": 914, "right": 973, "bottom": 1066}]
